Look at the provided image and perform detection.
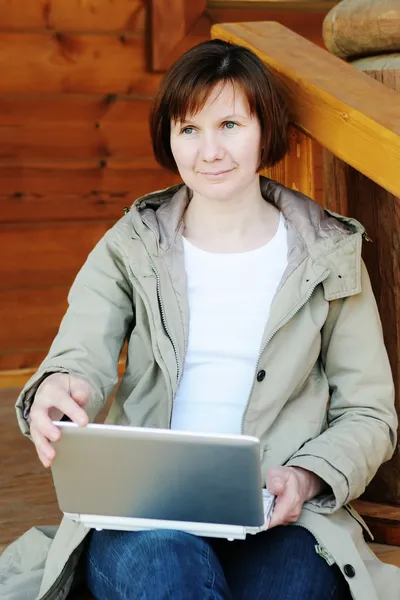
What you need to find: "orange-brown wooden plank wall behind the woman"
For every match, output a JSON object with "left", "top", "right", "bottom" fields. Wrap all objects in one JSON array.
[{"left": 0, "top": 0, "right": 334, "bottom": 386}]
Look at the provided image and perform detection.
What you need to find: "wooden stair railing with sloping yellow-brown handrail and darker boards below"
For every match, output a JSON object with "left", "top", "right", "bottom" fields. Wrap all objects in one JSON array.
[{"left": 211, "top": 22, "right": 400, "bottom": 545}]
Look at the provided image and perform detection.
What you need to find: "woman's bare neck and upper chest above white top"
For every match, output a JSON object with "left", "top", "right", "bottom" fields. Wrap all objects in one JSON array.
[{"left": 183, "top": 182, "right": 279, "bottom": 253}]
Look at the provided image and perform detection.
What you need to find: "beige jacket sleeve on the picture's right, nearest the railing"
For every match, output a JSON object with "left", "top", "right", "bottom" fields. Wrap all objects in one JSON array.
[{"left": 286, "top": 264, "right": 398, "bottom": 512}]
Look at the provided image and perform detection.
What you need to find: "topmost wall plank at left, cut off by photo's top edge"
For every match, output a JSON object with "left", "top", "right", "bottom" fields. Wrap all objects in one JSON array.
[{"left": 0, "top": 0, "right": 146, "bottom": 35}]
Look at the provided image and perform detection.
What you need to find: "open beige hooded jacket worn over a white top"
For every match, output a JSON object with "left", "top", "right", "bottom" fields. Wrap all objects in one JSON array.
[{"left": 0, "top": 178, "right": 400, "bottom": 600}]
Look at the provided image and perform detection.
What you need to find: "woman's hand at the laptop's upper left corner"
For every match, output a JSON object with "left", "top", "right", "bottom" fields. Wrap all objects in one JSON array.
[{"left": 29, "top": 373, "right": 90, "bottom": 467}]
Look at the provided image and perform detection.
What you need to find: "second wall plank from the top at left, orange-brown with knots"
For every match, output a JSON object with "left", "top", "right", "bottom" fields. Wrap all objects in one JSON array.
[{"left": 0, "top": 33, "right": 160, "bottom": 95}]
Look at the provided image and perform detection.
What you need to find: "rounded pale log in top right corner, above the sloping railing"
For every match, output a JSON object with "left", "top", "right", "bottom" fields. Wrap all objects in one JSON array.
[{"left": 323, "top": 0, "right": 400, "bottom": 59}]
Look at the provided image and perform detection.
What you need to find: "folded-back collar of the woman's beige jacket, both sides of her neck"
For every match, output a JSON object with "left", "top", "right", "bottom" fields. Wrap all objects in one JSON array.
[{"left": 131, "top": 177, "right": 365, "bottom": 300}]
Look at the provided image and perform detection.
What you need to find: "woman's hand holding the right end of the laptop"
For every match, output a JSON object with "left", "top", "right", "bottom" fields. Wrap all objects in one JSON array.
[{"left": 267, "top": 467, "right": 326, "bottom": 528}]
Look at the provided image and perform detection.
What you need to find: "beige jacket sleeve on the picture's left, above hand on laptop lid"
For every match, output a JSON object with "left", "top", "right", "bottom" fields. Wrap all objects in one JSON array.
[{"left": 16, "top": 229, "right": 133, "bottom": 436}]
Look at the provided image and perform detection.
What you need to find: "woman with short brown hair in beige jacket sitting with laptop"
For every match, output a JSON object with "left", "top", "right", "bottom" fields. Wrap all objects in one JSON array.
[{"left": 9, "top": 40, "right": 400, "bottom": 600}]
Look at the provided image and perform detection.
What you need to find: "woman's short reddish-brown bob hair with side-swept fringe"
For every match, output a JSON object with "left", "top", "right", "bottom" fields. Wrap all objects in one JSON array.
[{"left": 150, "top": 39, "right": 289, "bottom": 173}]
